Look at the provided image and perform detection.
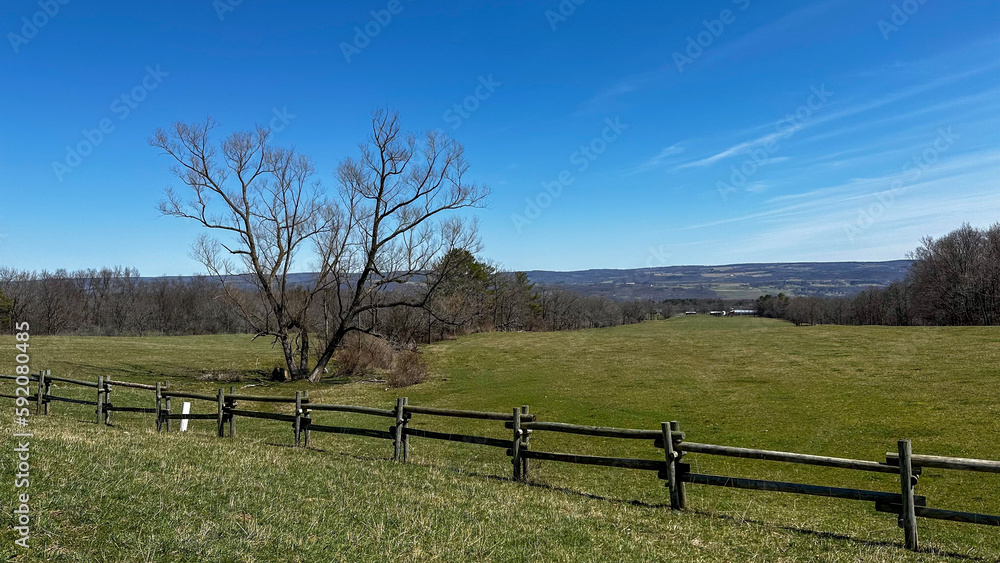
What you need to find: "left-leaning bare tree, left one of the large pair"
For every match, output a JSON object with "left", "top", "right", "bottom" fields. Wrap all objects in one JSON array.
[{"left": 150, "top": 115, "right": 340, "bottom": 374}]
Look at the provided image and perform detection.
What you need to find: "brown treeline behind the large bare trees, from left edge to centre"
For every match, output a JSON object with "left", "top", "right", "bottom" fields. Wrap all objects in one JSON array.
[{"left": 0, "top": 251, "right": 654, "bottom": 340}]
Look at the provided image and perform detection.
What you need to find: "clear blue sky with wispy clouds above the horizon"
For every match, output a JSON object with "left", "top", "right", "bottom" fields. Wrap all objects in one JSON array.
[{"left": 0, "top": 0, "right": 1000, "bottom": 275}]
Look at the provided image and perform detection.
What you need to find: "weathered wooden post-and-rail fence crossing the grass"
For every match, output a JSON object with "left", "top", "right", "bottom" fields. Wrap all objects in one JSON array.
[{"left": 0, "top": 371, "right": 1000, "bottom": 550}]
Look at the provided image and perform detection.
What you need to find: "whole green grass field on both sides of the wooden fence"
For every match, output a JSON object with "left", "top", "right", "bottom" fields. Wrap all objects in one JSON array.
[{"left": 0, "top": 317, "right": 1000, "bottom": 561}]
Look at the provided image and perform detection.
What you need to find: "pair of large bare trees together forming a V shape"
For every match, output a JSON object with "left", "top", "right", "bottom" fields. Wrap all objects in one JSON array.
[{"left": 150, "top": 111, "right": 488, "bottom": 381}]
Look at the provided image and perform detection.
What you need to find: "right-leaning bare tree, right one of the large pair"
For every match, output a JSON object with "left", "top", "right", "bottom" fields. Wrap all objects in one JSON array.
[{"left": 309, "top": 110, "right": 489, "bottom": 381}]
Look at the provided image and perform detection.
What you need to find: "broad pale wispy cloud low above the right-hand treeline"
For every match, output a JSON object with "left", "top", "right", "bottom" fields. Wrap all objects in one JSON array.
[{"left": 664, "top": 149, "right": 1000, "bottom": 263}]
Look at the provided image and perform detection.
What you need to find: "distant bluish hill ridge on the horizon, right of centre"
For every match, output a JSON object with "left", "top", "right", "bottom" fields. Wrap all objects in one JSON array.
[{"left": 528, "top": 260, "right": 910, "bottom": 301}]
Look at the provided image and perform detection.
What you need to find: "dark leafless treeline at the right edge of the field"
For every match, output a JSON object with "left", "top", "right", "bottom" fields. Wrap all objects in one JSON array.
[{"left": 757, "top": 223, "right": 1000, "bottom": 326}]
